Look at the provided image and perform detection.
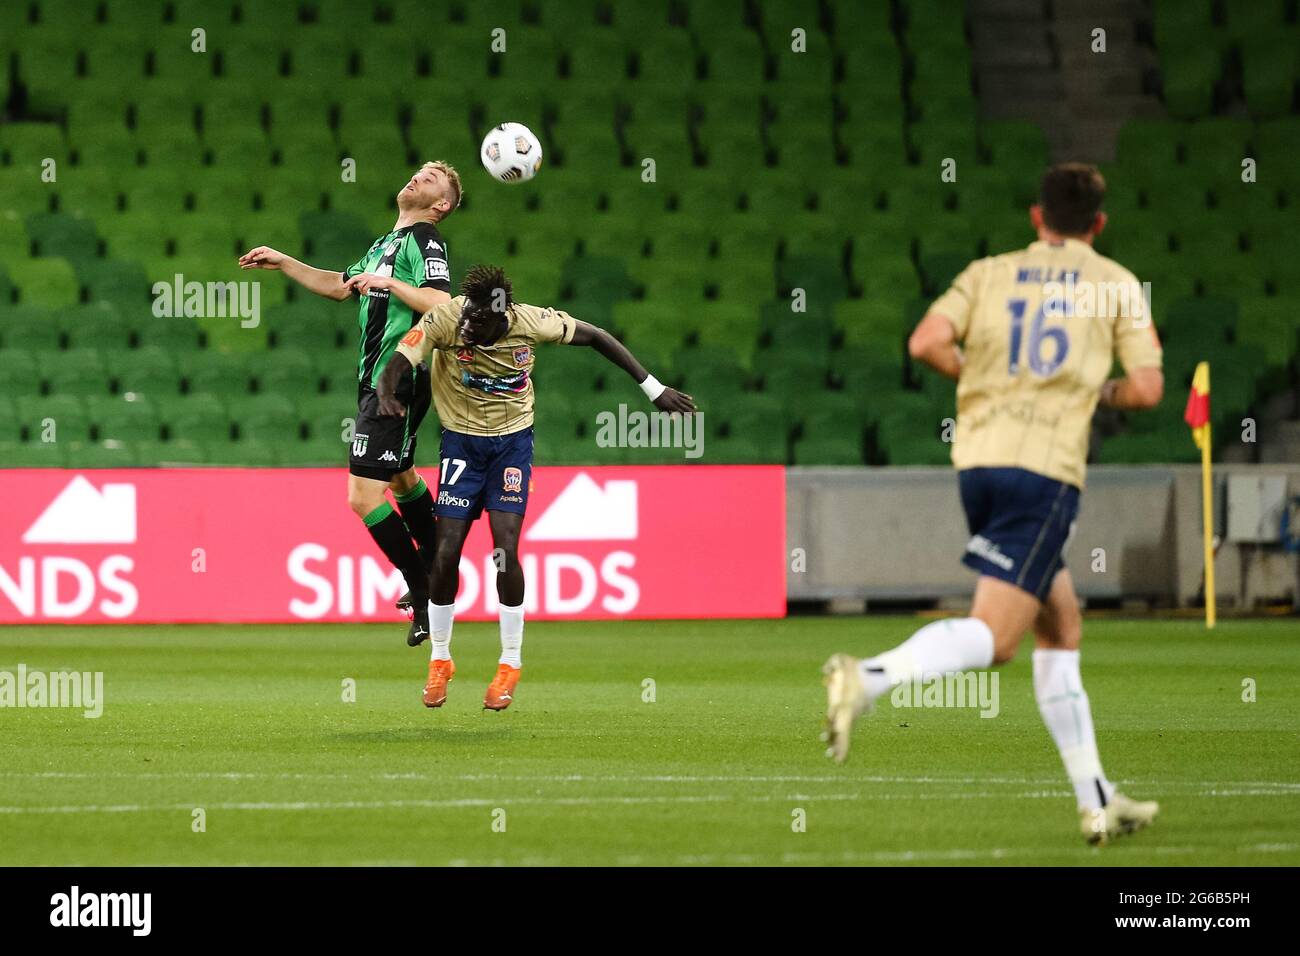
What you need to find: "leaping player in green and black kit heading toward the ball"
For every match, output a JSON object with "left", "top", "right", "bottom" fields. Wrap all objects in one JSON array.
[{"left": 239, "top": 163, "right": 460, "bottom": 646}]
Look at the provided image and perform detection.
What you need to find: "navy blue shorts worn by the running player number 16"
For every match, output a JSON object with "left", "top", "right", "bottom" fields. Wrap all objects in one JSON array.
[{"left": 957, "top": 468, "right": 1079, "bottom": 601}]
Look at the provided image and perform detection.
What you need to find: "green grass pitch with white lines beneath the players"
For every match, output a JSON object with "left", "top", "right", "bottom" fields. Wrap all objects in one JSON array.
[{"left": 0, "top": 618, "right": 1300, "bottom": 865}]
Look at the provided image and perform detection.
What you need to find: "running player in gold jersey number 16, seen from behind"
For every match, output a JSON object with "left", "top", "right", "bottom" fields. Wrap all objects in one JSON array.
[{"left": 823, "top": 163, "right": 1164, "bottom": 844}]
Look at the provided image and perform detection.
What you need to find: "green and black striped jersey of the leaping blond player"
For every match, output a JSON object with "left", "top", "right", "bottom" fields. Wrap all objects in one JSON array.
[{"left": 343, "top": 222, "right": 451, "bottom": 389}]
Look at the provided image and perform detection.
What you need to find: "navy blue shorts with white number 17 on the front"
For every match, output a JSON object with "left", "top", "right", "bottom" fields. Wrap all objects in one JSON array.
[{"left": 433, "top": 427, "right": 533, "bottom": 522}]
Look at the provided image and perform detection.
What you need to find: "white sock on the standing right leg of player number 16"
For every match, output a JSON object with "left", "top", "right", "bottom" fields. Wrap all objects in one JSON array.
[{"left": 1034, "top": 648, "right": 1115, "bottom": 810}]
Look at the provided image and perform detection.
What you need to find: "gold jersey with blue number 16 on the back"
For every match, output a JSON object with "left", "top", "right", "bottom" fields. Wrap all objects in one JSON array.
[{"left": 930, "top": 239, "right": 1161, "bottom": 488}]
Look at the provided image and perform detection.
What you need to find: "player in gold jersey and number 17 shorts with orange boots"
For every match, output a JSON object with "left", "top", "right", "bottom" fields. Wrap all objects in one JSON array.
[{"left": 378, "top": 265, "right": 696, "bottom": 710}]
